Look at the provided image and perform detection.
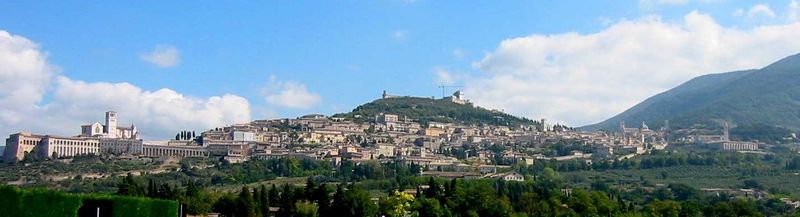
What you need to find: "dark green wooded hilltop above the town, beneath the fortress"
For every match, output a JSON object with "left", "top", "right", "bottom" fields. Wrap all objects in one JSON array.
[{"left": 334, "top": 97, "right": 537, "bottom": 126}]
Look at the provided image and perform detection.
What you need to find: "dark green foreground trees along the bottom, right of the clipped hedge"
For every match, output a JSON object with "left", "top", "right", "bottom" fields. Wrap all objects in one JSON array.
[{"left": 119, "top": 170, "right": 797, "bottom": 217}]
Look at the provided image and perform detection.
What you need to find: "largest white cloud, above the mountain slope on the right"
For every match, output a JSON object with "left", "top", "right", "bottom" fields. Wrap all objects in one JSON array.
[{"left": 465, "top": 12, "right": 800, "bottom": 125}]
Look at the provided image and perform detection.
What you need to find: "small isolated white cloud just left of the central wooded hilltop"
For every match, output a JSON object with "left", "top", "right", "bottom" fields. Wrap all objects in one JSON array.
[{"left": 262, "top": 75, "right": 322, "bottom": 109}]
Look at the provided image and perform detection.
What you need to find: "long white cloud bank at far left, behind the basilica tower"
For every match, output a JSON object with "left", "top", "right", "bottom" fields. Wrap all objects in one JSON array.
[{"left": 0, "top": 30, "right": 250, "bottom": 139}]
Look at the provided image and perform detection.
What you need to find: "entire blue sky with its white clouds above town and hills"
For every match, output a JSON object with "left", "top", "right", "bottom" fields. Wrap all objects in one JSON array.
[{"left": 0, "top": 0, "right": 800, "bottom": 139}]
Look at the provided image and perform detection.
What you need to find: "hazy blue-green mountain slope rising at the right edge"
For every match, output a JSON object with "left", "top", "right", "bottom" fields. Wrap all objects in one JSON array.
[{"left": 580, "top": 54, "right": 800, "bottom": 130}]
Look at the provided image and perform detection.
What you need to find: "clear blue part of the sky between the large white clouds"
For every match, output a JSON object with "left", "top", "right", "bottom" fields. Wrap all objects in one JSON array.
[{"left": 0, "top": 0, "right": 796, "bottom": 138}]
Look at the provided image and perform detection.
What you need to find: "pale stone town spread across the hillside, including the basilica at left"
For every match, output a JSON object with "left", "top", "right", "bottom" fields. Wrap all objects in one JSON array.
[{"left": 3, "top": 91, "right": 759, "bottom": 180}]
